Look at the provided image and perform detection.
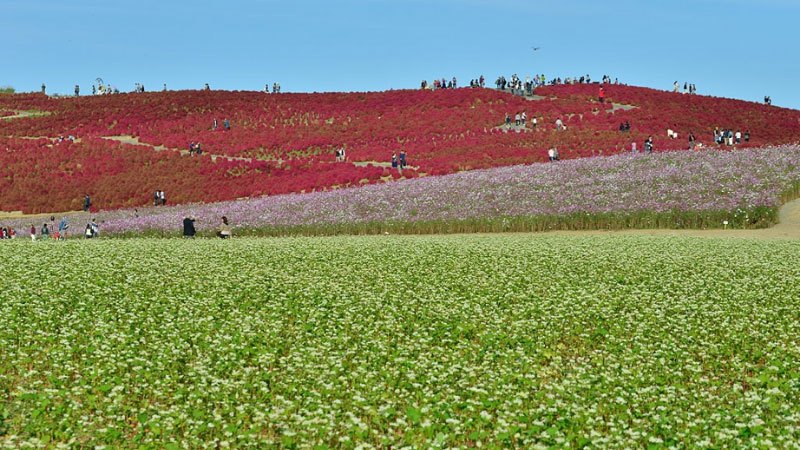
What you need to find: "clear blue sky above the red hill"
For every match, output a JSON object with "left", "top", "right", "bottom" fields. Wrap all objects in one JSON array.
[{"left": 0, "top": 0, "right": 800, "bottom": 109}]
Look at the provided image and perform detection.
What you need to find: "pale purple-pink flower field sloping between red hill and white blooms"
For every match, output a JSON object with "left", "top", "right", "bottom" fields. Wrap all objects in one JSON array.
[{"left": 0, "top": 146, "right": 800, "bottom": 236}]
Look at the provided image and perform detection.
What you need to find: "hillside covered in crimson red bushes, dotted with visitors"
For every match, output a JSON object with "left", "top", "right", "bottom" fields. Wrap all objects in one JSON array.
[{"left": 0, "top": 85, "right": 800, "bottom": 213}]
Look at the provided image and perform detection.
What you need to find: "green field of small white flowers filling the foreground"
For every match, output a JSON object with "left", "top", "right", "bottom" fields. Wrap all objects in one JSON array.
[{"left": 0, "top": 235, "right": 800, "bottom": 449}]
